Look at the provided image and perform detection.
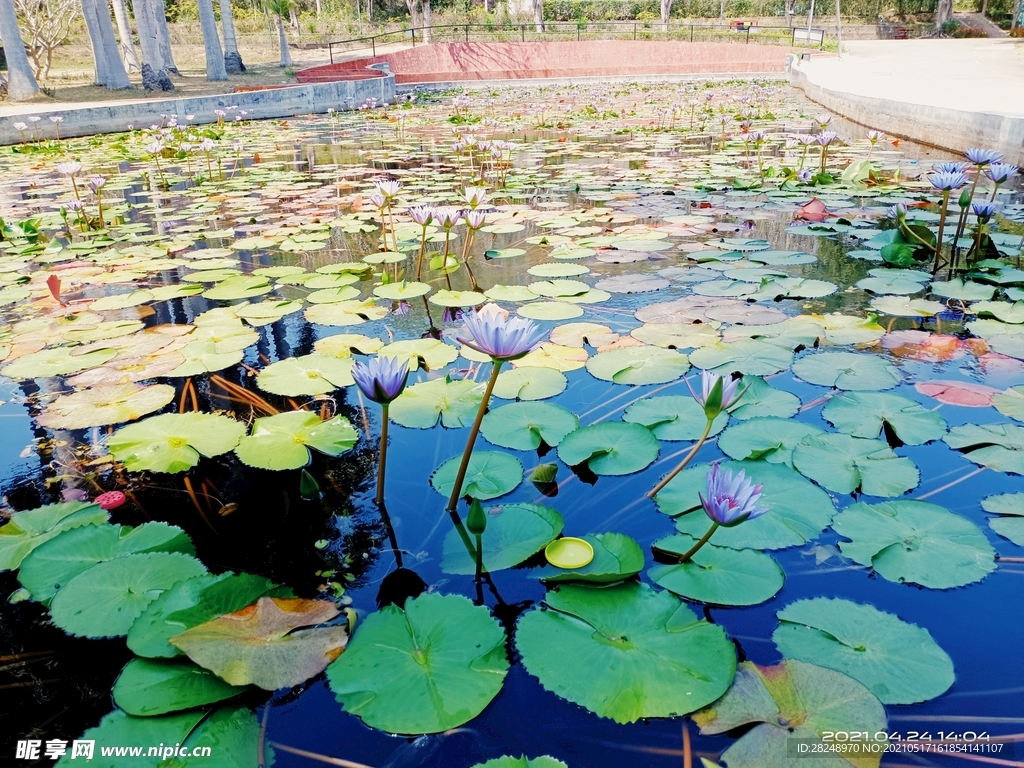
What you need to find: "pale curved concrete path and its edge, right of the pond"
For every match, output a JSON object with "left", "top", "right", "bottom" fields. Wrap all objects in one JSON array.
[{"left": 790, "top": 37, "right": 1024, "bottom": 165}]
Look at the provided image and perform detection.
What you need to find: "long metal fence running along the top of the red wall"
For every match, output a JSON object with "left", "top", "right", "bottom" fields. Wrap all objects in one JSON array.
[{"left": 327, "top": 22, "right": 835, "bottom": 63}]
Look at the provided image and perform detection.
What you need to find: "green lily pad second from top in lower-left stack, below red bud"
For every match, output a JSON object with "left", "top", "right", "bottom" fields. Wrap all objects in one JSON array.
[{"left": 17, "top": 522, "right": 196, "bottom": 602}]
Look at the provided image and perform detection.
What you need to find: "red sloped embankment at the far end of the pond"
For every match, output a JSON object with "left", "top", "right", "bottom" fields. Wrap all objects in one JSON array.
[{"left": 296, "top": 40, "right": 790, "bottom": 83}]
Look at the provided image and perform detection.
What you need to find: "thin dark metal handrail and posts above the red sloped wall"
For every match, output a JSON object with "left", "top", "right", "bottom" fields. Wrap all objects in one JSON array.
[{"left": 328, "top": 20, "right": 825, "bottom": 63}]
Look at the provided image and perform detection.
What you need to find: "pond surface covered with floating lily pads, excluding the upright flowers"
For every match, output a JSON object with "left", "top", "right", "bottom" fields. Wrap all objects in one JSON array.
[{"left": 0, "top": 82, "right": 1024, "bottom": 768}]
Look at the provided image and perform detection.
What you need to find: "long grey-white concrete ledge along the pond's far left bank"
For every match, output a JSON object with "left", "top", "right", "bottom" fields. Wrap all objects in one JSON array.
[{"left": 0, "top": 74, "right": 395, "bottom": 144}]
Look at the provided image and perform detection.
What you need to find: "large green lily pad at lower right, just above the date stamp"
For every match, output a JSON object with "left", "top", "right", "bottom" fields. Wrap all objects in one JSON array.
[{"left": 772, "top": 597, "right": 955, "bottom": 705}]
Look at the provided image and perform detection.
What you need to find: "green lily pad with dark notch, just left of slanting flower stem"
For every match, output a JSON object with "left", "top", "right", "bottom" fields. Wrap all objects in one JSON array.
[{"left": 558, "top": 422, "right": 660, "bottom": 475}]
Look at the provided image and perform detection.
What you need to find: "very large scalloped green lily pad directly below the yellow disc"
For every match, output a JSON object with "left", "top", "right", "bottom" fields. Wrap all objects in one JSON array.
[{"left": 515, "top": 583, "right": 736, "bottom": 723}]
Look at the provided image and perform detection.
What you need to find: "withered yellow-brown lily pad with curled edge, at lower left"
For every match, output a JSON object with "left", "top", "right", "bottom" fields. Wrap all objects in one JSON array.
[{"left": 169, "top": 597, "right": 348, "bottom": 690}]
